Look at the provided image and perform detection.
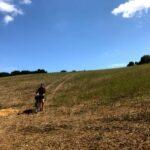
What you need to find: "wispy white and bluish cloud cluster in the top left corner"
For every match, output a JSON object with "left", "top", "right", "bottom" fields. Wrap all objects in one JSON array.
[{"left": 0, "top": 0, "right": 32, "bottom": 24}]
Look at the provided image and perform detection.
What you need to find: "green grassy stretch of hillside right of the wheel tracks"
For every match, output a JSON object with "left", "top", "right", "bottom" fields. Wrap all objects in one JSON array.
[{"left": 54, "top": 65, "right": 150, "bottom": 105}]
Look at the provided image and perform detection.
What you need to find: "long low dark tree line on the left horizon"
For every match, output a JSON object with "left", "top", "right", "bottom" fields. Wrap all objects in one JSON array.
[{"left": 0, "top": 69, "right": 47, "bottom": 77}]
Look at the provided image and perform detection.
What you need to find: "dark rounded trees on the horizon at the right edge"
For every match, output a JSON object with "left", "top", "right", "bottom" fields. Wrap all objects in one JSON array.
[{"left": 127, "top": 55, "right": 150, "bottom": 67}]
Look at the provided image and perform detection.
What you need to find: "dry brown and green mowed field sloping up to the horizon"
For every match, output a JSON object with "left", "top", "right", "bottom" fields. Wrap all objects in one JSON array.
[{"left": 0, "top": 65, "right": 150, "bottom": 150}]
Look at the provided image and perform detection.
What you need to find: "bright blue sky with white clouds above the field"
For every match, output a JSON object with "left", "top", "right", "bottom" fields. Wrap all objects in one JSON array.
[{"left": 0, "top": 0, "right": 150, "bottom": 72}]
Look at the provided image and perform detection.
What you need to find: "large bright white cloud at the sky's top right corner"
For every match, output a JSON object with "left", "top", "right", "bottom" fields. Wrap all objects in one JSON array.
[{"left": 112, "top": 0, "right": 150, "bottom": 18}]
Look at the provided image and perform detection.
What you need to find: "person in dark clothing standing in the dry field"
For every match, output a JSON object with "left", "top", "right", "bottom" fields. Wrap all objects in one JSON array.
[{"left": 35, "top": 83, "right": 46, "bottom": 111}]
